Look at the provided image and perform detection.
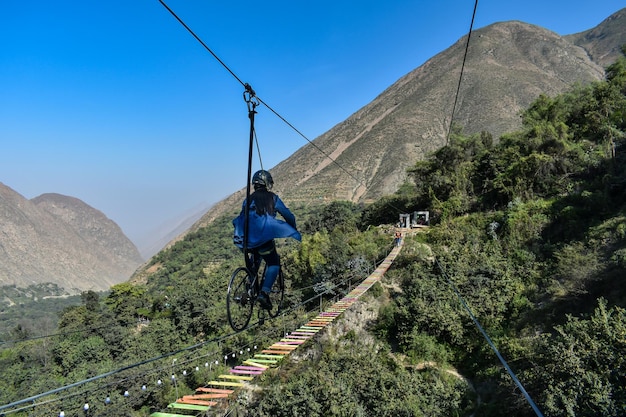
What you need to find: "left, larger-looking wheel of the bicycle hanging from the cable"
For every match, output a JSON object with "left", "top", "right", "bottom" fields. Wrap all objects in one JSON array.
[{"left": 226, "top": 267, "right": 254, "bottom": 331}]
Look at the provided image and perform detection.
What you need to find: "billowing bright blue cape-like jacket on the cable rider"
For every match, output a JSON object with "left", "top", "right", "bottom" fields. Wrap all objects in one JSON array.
[{"left": 233, "top": 194, "right": 302, "bottom": 249}]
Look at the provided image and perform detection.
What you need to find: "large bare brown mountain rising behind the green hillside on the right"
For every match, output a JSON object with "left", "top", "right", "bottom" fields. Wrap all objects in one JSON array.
[{"left": 183, "top": 9, "right": 626, "bottom": 234}]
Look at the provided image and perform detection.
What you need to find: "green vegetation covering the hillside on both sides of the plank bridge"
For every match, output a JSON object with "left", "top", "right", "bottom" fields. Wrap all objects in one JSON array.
[{"left": 0, "top": 53, "right": 626, "bottom": 416}]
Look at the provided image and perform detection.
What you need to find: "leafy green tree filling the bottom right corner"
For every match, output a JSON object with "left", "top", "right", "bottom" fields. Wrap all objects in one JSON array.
[{"left": 525, "top": 299, "right": 626, "bottom": 417}]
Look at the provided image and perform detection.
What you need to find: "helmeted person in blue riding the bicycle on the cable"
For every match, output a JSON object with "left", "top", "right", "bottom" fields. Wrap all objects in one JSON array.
[{"left": 233, "top": 170, "right": 302, "bottom": 310}]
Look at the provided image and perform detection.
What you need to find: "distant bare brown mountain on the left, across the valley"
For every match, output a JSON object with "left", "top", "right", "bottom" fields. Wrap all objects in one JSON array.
[{"left": 0, "top": 183, "right": 142, "bottom": 294}]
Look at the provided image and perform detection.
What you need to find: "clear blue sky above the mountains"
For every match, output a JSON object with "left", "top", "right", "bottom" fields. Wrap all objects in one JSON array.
[{"left": 0, "top": 0, "right": 624, "bottom": 241}]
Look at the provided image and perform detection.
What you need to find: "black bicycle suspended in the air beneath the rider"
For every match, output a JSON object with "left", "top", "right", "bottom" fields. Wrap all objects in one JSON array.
[{"left": 226, "top": 247, "right": 285, "bottom": 331}]
